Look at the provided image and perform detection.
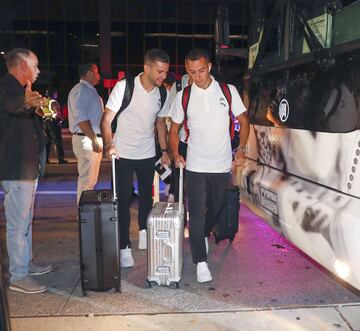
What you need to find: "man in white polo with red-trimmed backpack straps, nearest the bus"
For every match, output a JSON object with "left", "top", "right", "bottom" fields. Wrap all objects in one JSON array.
[{"left": 169, "top": 49, "right": 249, "bottom": 283}]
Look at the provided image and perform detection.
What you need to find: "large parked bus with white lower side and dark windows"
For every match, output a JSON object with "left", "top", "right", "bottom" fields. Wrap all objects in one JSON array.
[{"left": 232, "top": 0, "right": 360, "bottom": 290}]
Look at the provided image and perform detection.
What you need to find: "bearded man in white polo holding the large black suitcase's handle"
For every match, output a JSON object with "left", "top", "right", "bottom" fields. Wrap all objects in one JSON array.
[{"left": 101, "top": 49, "right": 170, "bottom": 267}]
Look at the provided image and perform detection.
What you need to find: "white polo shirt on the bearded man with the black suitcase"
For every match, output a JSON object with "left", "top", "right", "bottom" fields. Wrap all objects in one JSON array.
[{"left": 106, "top": 74, "right": 169, "bottom": 160}]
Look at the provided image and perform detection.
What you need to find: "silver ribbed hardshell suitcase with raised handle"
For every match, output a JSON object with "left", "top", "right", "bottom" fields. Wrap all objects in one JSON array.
[{"left": 147, "top": 168, "right": 184, "bottom": 288}]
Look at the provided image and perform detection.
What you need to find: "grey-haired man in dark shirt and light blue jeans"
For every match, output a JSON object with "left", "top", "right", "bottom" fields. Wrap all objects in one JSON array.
[{"left": 0, "top": 48, "right": 52, "bottom": 294}]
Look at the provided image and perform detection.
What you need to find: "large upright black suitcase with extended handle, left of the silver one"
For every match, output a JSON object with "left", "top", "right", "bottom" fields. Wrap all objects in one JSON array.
[{"left": 78, "top": 160, "right": 121, "bottom": 296}]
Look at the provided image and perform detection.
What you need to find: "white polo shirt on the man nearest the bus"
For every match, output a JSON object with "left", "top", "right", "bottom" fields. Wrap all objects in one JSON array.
[{"left": 170, "top": 79, "right": 246, "bottom": 173}]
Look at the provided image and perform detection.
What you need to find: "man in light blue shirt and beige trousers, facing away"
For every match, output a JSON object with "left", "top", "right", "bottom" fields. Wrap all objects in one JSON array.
[{"left": 68, "top": 63, "right": 104, "bottom": 204}]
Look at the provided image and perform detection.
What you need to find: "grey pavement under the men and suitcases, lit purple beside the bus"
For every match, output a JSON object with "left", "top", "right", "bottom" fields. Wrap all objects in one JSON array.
[{"left": 0, "top": 137, "right": 360, "bottom": 330}]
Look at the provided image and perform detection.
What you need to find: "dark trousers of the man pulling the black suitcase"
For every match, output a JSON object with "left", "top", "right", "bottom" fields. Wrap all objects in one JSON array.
[{"left": 116, "top": 157, "right": 155, "bottom": 249}]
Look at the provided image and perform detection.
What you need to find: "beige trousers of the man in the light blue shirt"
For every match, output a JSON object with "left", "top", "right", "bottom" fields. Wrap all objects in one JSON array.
[{"left": 72, "top": 135, "right": 102, "bottom": 204}]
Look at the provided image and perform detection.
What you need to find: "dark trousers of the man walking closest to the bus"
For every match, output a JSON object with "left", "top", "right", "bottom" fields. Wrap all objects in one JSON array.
[{"left": 186, "top": 170, "right": 229, "bottom": 263}]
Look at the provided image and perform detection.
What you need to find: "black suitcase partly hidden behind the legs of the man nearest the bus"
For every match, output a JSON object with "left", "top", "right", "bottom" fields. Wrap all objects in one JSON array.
[{"left": 214, "top": 186, "right": 240, "bottom": 244}]
